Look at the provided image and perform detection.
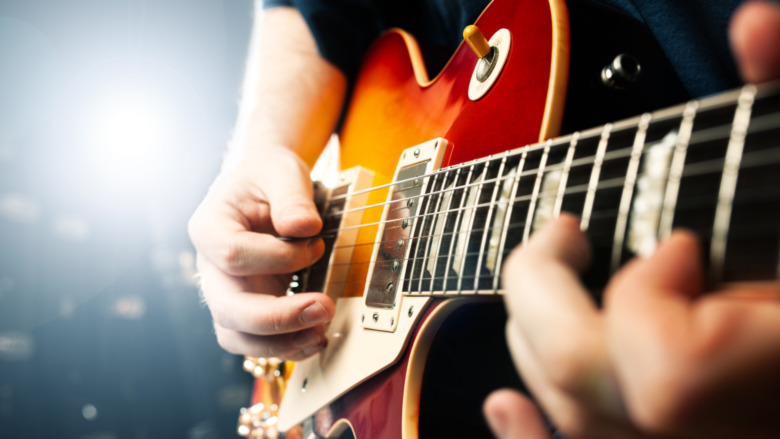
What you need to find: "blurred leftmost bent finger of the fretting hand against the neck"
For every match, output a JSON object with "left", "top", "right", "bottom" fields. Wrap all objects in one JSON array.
[{"left": 503, "top": 215, "right": 599, "bottom": 361}]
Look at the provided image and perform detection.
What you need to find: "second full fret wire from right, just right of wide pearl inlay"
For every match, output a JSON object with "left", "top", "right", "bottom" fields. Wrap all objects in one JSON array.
[{"left": 658, "top": 101, "right": 699, "bottom": 239}]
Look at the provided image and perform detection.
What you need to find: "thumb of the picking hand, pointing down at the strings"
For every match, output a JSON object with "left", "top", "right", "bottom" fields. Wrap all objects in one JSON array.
[{"left": 259, "top": 150, "right": 322, "bottom": 238}]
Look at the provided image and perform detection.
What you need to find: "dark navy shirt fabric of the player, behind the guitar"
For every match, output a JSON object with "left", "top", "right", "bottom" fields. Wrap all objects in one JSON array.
[{"left": 263, "top": 0, "right": 741, "bottom": 97}]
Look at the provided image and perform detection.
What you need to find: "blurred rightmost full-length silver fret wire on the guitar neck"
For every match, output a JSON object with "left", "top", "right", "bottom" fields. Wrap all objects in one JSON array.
[{"left": 709, "top": 85, "right": 756, "bottom": 284}]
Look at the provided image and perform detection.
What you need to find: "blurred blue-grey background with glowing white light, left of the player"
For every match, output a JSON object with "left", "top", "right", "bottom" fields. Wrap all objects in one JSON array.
[{"left": 0, "top": 0, "right": 253, "bottom": 439}]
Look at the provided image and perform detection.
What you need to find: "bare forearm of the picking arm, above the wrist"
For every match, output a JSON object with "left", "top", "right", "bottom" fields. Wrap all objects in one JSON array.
[{"left": 227, "top": 8, "right": 347, "bottom": 167}]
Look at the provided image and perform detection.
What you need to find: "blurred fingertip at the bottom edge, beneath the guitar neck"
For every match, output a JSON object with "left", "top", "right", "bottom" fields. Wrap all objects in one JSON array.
[{"left": 483, "top": 389, "right": 550, "bottom": 439}]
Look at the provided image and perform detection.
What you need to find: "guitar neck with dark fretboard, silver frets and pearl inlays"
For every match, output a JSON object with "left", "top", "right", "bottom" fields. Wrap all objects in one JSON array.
[{"left": 390, "top": 85, "right": 780, "bottom": 295}]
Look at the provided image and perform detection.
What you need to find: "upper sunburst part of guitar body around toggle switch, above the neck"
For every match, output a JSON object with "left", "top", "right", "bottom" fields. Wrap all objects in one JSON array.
[{"left": 340, "top": 0, "right": 569, "bottom": 296}]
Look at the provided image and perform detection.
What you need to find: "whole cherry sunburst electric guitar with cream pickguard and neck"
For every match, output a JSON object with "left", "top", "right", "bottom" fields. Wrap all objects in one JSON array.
[{"left": 239, "top": 0, "right": 780, "bottom": 438}]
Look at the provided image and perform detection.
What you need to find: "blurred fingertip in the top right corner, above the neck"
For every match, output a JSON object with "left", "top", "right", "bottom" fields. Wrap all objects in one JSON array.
[{"left": 729, "top": 1, "right": 780, "bottom": 83}]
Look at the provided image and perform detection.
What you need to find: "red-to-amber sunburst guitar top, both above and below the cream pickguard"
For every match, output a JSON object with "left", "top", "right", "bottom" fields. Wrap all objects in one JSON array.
[{"left": 247, "top": 0, "right": 569, "bottom": 438}]
